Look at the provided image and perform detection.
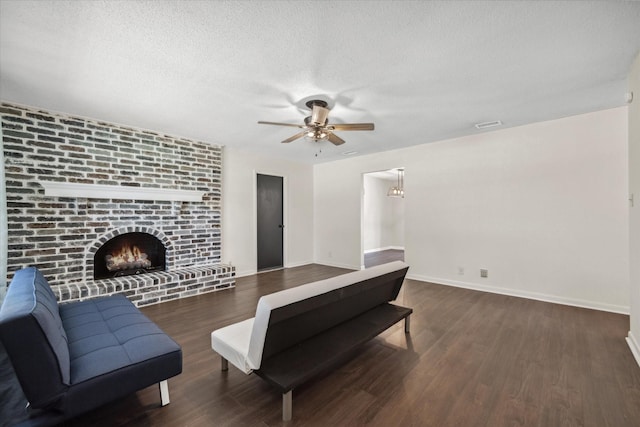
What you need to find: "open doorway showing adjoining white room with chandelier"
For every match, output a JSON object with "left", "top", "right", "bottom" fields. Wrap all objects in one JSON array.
[{"left": 362, "top": 168, "right": 405, "bottom": 268}]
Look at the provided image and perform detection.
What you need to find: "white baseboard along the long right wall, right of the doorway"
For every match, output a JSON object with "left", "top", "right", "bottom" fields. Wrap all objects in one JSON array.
[{"left": 407, "top": 274, "right": 630, "bottom": 315}]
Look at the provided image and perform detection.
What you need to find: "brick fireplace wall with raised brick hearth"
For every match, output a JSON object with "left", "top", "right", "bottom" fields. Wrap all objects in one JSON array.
[{"left": 0, "top": 103, "right": 235, "bottom": 306}]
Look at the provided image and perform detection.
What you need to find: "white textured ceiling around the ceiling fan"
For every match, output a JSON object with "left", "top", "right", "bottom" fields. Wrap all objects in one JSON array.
[{"left": 0, "top": 0, "right": 640, "bottom": 163}]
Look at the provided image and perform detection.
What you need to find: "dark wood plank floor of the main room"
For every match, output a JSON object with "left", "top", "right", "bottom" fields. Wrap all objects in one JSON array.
[{"left": 1, "top": 265, "right": 640, "bottom": 427}]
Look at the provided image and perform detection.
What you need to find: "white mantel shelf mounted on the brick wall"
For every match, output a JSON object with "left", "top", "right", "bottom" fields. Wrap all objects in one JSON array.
[{"left": 40, "top": 181, "right": 205, "bottom": 202}]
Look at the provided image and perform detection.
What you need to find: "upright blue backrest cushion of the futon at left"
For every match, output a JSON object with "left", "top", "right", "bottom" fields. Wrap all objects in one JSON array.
[{"left": 0, "top": 267, "right": 71, "bottom": 385}]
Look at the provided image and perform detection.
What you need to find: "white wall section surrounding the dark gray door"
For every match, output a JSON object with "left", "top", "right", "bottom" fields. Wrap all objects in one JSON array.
[{"left": 222, "top": 147, "right": 313, "bottom": 276}]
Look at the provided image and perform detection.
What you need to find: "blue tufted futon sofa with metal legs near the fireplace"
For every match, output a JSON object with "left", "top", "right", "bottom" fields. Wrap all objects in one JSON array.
[{"left": 0, "top": 267, "right": 182, "bottom": 424}]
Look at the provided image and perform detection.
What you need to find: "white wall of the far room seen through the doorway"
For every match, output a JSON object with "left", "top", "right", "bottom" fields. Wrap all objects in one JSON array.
[{"left": 363, "top": 174, "right": 404, "bottom": 252}]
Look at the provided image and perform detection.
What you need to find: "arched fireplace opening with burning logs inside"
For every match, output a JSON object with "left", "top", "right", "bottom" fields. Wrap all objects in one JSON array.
[{"left": 93, "top": 232, "right": 166, "bottom": 280}]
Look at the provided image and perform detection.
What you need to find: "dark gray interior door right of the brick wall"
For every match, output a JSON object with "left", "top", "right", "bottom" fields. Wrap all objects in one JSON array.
[{"left": 257, "top": 174, "right": 284, "bottom": 271}]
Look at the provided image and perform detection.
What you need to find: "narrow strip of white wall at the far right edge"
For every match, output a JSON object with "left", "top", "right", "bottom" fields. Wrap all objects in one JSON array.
[{"left": 627, "top": 54, "right": 640, "bottom": 365}]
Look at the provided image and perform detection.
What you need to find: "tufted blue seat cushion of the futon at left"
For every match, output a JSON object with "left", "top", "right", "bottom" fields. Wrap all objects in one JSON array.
[{"left": 57, "top": 295, "right": 182, "bottom": 416}]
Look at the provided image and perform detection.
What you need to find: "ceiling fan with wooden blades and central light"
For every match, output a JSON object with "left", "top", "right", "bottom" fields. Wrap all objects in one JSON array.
[{"left": 258, "top": 99, "right": 374, "bottom": 145}]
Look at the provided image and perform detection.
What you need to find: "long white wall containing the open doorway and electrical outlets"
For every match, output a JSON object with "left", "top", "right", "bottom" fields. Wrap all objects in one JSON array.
[{"left": 314, "top": 107, "right": 629, "bottom": 312}]
